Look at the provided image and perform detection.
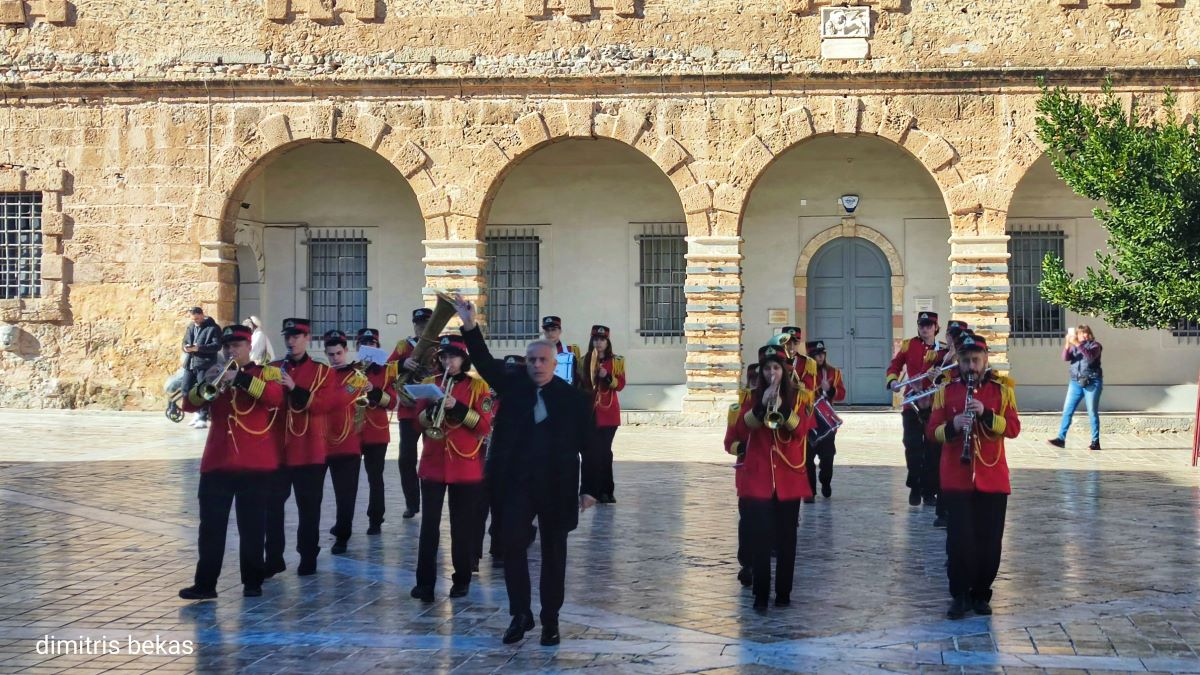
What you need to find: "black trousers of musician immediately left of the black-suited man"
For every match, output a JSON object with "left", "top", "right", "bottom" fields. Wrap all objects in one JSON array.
[{"left": 416, "top": 480, "right": 484, "bottom": 589}]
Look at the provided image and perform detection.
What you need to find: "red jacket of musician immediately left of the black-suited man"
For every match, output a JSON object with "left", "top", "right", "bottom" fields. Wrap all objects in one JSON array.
[{"left": 416, "top": 374, "right": 493, "bottom": 484}]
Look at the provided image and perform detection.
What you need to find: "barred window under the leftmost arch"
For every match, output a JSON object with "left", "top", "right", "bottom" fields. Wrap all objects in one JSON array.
[{"left": 305, "top": 229, "right": 370, "bottom": 340}]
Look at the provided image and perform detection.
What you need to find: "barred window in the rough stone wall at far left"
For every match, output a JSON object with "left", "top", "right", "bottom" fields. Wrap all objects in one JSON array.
[{"left": 0, "top": 192, "right": 42, "bottom": 300}]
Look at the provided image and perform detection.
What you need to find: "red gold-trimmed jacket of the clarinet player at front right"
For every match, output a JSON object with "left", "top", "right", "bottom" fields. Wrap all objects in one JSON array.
[{"left": 925, "top": 371, "right": 1021, "bottom": 495}]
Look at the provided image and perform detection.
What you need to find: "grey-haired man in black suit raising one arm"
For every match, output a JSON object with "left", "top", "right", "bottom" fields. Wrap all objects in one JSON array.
[{"left": 456, "top": 295, "right": 596, "bottom": 646}]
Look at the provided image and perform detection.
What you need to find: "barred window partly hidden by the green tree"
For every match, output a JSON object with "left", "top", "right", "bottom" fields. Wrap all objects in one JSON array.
[{"left": 1008, "top": 227, "right": 1066, "bottom": 338}]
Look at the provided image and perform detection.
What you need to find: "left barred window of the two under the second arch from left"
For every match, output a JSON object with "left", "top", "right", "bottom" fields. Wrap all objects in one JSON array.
[{"left": 485, "top": 227, "right": 541, "bottom": 340}]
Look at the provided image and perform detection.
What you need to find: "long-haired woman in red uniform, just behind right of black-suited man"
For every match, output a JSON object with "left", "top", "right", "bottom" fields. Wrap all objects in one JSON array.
[{"left": 583, "top": 325, "right": 625, "bottom": 504}]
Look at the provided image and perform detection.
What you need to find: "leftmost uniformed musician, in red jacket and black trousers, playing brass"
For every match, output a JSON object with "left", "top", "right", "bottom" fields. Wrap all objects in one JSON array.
[{"left": 179, "top": 325, "right": 283, "bottom": 601}]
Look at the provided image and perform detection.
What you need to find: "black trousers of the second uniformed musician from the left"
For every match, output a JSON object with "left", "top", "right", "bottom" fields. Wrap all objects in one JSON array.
[{"left": 266, "top": 464, "right": 325, "bottom": 567}]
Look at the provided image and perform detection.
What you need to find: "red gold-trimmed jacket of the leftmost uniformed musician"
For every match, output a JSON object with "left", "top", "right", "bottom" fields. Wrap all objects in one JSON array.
[{"left": 182, "top": 363, "right": 283, "bottom": 473}]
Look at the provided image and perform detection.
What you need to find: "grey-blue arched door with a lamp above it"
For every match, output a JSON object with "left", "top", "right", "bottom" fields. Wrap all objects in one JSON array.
[{"left": 805, "top": 237, "right": 892, "bottom": 405}]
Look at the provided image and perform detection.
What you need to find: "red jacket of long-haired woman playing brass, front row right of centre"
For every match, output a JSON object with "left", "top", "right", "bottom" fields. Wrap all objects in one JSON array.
[{"left": 725, "top": 392, "right": 814, "bottom": 501}]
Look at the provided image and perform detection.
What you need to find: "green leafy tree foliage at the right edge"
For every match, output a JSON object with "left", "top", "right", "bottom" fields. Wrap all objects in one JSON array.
[{"left": 1037, "top": 82, "right": 1200, "bottom": 328}]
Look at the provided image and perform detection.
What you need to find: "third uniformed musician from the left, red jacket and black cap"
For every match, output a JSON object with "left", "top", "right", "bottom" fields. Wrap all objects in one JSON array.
[{"left": 323, "top": 330, "right": 372, "bottom": 555}]
